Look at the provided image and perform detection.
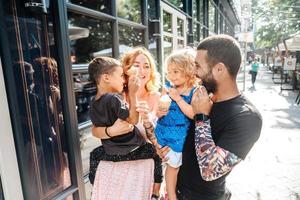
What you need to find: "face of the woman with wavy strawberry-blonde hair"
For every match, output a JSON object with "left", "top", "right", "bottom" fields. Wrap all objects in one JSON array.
[{"left": 133, "top": 54, "right": 151, "bottom": 85}]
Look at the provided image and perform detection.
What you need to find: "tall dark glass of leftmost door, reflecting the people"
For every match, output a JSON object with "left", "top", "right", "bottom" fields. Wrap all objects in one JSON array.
[{"left": 3, "top": 1, "right": 71, "bottom": 200}]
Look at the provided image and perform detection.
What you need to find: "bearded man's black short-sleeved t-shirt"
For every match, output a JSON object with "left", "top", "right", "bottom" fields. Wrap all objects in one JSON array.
[{"left": 177, "top": 95, "right": 262, "bottom": 200}]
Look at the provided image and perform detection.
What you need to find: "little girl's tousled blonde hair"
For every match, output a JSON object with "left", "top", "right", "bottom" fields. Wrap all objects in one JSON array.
[{"left": 165, "top": 49, "right": 196, "bottom": 87}]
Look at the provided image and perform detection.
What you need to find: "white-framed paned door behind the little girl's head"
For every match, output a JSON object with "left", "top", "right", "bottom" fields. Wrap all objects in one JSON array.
[{"left": 161, "top": 2, "right": 187, "bottom": 80}]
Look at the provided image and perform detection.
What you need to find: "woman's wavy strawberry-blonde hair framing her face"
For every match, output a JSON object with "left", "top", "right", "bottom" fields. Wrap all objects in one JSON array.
[{"left": 121, "top": 47, "right": 160, "bottom": 92}]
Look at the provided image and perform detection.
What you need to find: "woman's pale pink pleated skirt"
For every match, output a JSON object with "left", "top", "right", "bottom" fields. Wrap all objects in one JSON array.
[{"left": 91, "top": 159, "right": 154, "bottom": 200}]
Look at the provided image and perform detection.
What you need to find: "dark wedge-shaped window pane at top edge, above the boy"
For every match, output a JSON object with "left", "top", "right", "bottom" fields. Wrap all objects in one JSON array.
[{"left": 70, "top": 0, "right": 111, "bottom": 14}]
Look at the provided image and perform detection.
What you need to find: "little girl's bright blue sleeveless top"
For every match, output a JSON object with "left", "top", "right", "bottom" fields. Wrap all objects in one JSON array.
[{"left": 155, "top": 88, "right": 195, "bottom": 152}]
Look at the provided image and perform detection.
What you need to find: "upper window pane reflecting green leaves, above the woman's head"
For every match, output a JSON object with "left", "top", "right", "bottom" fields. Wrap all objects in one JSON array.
[{"left": 117, "top": 0, "right": 142, "bottom": 23}]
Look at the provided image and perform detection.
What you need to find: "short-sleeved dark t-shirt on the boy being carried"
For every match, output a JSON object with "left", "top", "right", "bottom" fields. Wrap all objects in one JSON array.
[{"left": 90, "top": 93, "right": 145, "bottom": 155}]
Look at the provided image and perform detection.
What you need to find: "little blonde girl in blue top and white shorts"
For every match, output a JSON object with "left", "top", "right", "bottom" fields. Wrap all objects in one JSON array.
[{"left": 155, "top": 49, "right": 196, "bottom": 200}]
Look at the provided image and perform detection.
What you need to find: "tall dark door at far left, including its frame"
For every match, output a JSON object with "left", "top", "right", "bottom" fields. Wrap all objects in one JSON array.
[{"left": 0, "top": 0, "right": 84, "bottom": 200}]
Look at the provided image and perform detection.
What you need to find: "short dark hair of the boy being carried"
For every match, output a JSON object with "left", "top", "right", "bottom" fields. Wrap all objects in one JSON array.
[{"left": 88, "top": 56, "right": 121, "bottom": 85}]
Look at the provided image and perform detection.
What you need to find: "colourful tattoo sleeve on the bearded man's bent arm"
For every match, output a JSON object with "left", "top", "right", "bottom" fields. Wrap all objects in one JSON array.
[{"left": 195, "top": 120, "right": 241, "bottom": 181}]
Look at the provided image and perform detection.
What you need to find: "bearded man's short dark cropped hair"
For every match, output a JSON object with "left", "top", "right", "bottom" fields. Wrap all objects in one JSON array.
[{"left": 197, "top": 35, "right": 242, "bottom": 77}]
